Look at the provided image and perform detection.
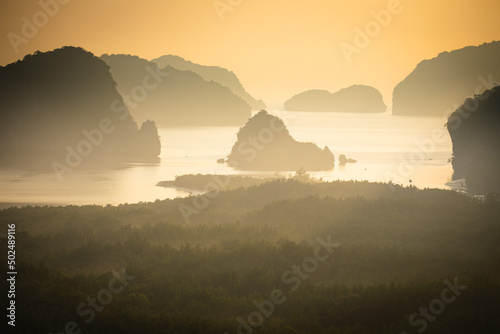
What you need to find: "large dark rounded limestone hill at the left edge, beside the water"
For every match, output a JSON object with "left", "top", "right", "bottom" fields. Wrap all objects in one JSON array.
[{"left": 0, "top": 47, "right": 160, "bottom": 171}]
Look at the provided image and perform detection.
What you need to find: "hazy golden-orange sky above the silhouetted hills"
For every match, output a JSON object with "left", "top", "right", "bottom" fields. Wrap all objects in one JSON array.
[{"left": 0, "top": 0, "right": 500, "bottom": 107}]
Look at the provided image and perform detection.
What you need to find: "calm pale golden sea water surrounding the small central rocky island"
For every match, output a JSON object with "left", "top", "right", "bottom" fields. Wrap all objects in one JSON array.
[{"left": 0, "top": 112, "right": 452, "bottom": 206}]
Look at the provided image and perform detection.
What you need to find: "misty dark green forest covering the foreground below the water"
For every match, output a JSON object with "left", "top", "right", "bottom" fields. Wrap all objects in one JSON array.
[{"left": 0, "top": 178, "right": 500, "bottom": 333}]
